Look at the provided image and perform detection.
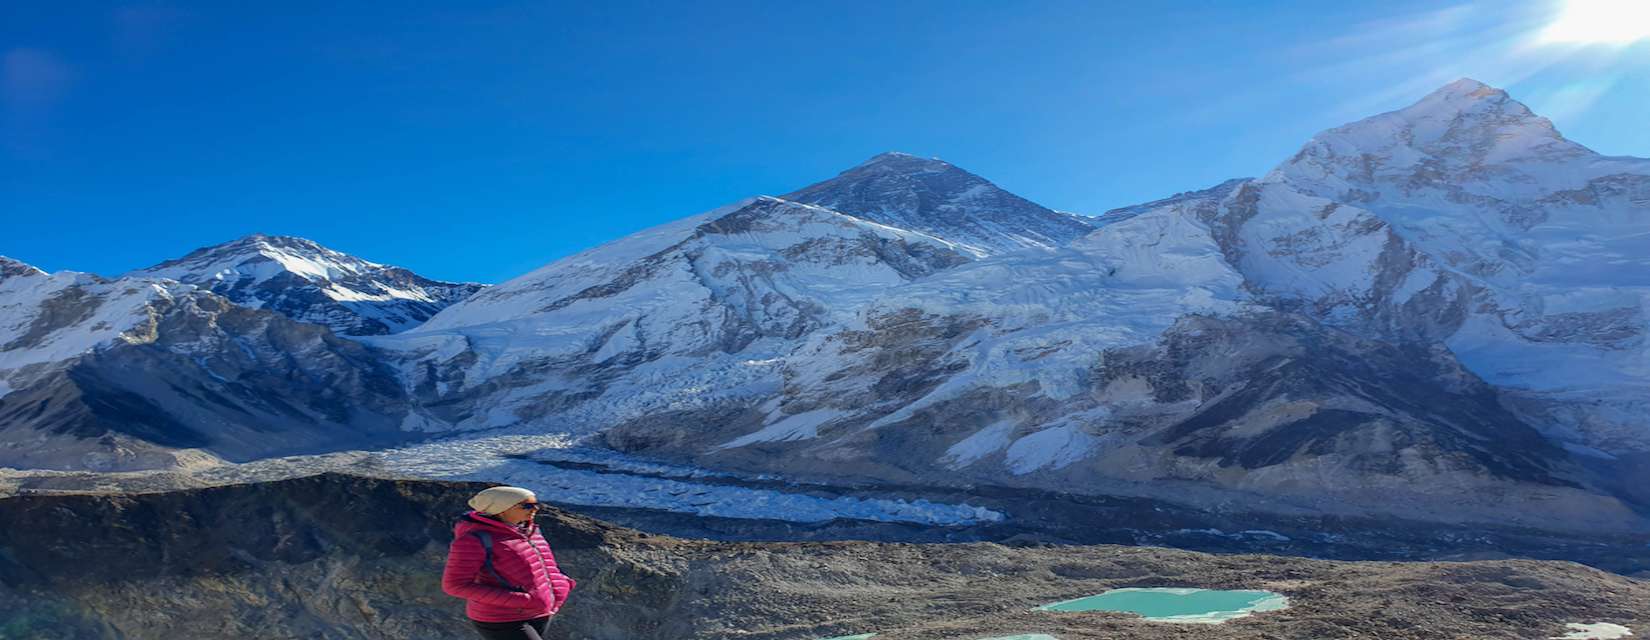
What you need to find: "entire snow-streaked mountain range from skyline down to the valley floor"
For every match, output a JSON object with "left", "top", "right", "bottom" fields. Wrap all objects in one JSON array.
[{"left": 0, "top": 79, "right": 1650, "bottom": 547}]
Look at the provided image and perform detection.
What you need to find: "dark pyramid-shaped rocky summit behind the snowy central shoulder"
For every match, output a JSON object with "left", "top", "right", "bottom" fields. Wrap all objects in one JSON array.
[{"left": 784, "top": 153, "right": 1094, "bottom": 256}]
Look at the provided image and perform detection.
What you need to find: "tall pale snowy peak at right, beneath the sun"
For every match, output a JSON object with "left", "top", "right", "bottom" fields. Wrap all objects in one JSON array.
[{"left": 1218, "top": 79, "right": 1650, "bottom": 439}]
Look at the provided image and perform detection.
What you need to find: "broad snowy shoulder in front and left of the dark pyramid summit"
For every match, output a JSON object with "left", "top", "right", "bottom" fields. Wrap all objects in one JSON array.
[{"left": 371, "top": 196, "right": 967, "bottom": 431}]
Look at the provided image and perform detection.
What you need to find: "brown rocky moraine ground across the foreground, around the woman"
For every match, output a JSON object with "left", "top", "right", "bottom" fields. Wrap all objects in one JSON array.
[{"left": 0, "top": 475, "right": 1650, "bottom": 640}]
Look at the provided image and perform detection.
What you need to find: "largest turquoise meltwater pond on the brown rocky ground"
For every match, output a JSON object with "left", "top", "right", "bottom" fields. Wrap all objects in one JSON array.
[{"left": 1038, "top": 587, "right": 1289, "bottom": 625}]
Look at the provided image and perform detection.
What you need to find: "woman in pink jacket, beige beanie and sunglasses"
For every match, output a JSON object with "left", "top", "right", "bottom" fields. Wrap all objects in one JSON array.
[{"left": 441, "top": 487, "right": 576, "bottom": 640}]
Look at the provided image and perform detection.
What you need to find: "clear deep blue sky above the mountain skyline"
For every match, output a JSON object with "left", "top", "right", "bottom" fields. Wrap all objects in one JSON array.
[{"left": 0, "top": 0, "right": 1650, "bottom": 282}]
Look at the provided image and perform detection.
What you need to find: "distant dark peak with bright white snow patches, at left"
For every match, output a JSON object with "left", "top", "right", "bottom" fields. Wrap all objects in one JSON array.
[{"left": 129, "top": 234, "right": 483, "bottom": 335}]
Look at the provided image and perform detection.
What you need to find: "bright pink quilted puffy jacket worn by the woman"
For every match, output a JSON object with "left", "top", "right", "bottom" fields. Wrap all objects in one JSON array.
[{"left": 441, "top": 511, "right": 576, "bottom": 622}]
